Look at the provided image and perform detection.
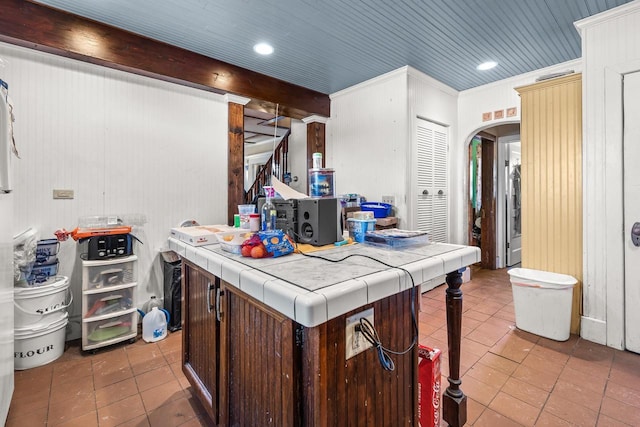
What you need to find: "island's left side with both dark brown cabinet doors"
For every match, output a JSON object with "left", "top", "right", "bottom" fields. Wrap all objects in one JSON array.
[{"left": 182, "top": 261, "right": 296, "bottom": 426}]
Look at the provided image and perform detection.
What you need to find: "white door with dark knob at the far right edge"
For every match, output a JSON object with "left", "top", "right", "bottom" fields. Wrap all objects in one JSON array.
[{"left": 623, "top": 72, "right": 640, "bottom": 353}]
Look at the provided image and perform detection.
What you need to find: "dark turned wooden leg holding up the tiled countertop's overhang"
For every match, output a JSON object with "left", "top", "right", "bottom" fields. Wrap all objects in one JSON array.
[{"left": 442, "top": 269, "right": 467, "bottom": 427}]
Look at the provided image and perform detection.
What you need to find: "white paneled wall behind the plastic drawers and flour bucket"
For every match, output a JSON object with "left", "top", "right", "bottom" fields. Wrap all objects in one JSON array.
[{"left": 0, "top": 43, "right": 227, "bottom": 338}]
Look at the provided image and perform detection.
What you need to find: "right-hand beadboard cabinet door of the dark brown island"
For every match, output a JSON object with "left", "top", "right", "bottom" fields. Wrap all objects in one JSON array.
[{"left": 220, "top": 282, "right": 300, "bottom": 426}]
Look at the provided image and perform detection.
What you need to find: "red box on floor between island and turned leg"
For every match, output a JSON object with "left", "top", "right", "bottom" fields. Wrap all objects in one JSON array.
[{"left": 418, "top": 344, "right": 442, "bottom": 427}]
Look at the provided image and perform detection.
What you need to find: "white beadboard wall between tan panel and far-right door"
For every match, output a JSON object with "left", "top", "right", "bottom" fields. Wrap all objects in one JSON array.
[{"left": 577, "top": 1, "right": 640, "bottom": 348}]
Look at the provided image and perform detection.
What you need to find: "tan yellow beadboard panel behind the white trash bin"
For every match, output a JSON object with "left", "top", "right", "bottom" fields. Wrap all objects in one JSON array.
[{"left": 517, "top": 74, "right": 582, "bottom": 333}]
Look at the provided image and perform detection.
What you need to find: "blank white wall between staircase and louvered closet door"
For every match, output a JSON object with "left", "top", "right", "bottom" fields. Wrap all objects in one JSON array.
[{"left": 325, "top": 69, "right": 409, "bottom": 219}]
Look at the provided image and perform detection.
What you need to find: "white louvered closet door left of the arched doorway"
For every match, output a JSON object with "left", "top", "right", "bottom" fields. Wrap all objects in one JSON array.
[{"left": 415, "top": 118, "right": 449, "bottom": 243}]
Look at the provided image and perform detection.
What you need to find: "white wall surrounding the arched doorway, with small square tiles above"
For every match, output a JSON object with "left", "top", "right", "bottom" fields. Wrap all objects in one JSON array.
[{"left": 450, "top": 59, "right": 582, "bottom": 244}]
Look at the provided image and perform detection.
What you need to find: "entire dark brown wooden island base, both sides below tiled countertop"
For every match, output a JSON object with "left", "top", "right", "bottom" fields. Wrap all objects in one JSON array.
[{"left": 182, "top": 261, "right": 417, "bottom": 426}]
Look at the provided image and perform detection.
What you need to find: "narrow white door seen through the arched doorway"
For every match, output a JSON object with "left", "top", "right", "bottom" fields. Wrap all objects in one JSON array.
[{"left": 506, "top": 142, "right": 522, "bottom": 267}]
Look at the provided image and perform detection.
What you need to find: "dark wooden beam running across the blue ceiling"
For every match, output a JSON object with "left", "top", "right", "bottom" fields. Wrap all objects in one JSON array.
[{"left": 0, "top": 0, "right": 330, "bottom": 119}]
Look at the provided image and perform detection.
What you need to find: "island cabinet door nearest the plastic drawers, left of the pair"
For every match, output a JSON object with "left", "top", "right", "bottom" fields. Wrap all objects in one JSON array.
[{"left": 182, "top": 261, "right": 220, "bottom": 424}]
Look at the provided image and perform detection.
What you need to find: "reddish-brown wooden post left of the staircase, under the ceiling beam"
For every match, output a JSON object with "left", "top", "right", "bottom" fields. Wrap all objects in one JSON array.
[{"left": 227, "top": 102, "right": 244, "bottom": 225}]
